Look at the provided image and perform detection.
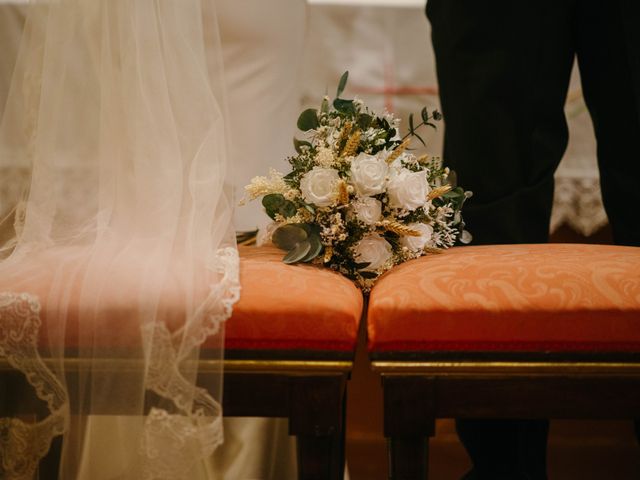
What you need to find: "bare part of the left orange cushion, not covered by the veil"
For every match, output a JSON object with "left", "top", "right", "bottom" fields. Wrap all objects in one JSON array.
[{"left": 225, "top": 247, "right": 362, "bottom": 351}]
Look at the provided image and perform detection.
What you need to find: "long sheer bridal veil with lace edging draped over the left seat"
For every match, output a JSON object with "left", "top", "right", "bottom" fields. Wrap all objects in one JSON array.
[{"left": 0, "top": 0, "right": 239, "bottom": 479}]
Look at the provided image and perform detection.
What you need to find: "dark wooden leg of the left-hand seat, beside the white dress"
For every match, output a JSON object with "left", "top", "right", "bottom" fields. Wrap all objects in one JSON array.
[{"left": 289, "top": 375, "right": 346, "bottom": 480}]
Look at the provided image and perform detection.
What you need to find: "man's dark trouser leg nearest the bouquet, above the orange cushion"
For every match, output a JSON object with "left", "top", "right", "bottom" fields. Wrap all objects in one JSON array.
[{"left": 427, "top": 0, "right": 574, "bottom": 244}]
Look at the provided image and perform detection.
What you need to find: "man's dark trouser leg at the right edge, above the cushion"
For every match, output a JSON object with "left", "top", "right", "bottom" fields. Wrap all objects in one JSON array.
[{"left": 576, "top": 0, "right": 640, "bottom": 245}]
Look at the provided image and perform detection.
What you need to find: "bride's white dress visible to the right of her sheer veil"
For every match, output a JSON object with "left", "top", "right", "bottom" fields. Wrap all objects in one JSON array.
[{"left": 207, "top": 0, "right": 306, "bottom": 480}]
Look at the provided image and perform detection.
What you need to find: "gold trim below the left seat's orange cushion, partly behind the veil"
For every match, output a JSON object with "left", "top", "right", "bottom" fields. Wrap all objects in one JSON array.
[{"left": 0, "top": 358, "right": 353, "bottom": 374}]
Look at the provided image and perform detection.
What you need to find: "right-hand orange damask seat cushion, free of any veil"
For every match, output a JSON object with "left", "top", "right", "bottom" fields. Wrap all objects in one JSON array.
[{"left": 368, "top": 244, "right": 640, "bottom": 352}]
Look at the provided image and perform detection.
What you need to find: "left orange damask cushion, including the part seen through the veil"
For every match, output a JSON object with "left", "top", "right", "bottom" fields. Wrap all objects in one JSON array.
[{"left": 0, "top": 247, "right": 363, "bottom": 352}]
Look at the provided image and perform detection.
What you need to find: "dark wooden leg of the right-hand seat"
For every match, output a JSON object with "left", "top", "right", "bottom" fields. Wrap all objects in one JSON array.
[{"left": 382, "top": 376, "right": 435, "bottom": 480}]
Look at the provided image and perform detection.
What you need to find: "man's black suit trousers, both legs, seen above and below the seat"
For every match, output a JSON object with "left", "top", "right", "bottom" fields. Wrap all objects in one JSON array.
[{"left": 427, "top": 0, "right": 640, "bottom": 480}]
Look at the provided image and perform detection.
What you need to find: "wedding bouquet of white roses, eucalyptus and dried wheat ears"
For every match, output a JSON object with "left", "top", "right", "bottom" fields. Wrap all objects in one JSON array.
[{"left": 245, "top": 72, "right": 471, "bottom": 291}]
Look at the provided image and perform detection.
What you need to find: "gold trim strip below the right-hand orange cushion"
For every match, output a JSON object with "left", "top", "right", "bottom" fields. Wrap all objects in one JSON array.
[{"left": 371, "top": 361, "right": 640, "bottom": 376}]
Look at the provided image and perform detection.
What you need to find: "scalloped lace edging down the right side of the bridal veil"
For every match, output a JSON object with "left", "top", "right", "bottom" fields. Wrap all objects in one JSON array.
[{"left": 141, "top": 248, "right": 240, "bottom": 480}]
